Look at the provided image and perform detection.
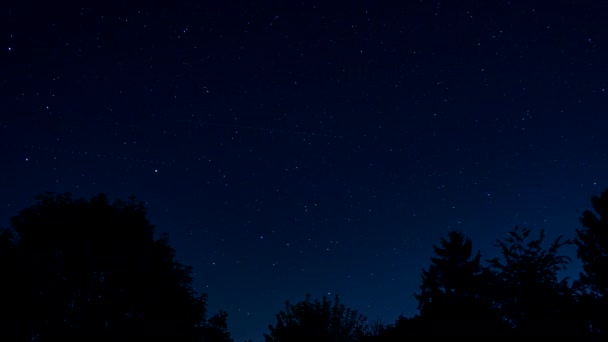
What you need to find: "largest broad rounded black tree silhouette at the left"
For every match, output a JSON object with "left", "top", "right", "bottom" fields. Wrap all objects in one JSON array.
[{"left": 0, "top": 193, "right": 213, "bottom": 341}]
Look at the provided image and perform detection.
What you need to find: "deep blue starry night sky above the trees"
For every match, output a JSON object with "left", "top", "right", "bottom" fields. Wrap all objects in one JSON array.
[{"left": 0, "top": 0, "right": 608, "bottom": 342}]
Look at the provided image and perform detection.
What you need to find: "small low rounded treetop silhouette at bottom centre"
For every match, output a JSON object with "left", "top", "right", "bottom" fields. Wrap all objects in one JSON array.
[{"left": 264, "top": 294, "right": 367, "bottom": 342}]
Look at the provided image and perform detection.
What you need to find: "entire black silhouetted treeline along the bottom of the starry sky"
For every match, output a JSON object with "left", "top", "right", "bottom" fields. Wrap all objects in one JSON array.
[{"left": 0, "top": 190, "right": 608, "bottom": 342}]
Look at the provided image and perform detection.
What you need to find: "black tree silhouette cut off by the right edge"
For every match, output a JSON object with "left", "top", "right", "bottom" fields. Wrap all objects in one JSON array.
[{"left": 574, "top": 190, "right": 608, "bottom": 338}]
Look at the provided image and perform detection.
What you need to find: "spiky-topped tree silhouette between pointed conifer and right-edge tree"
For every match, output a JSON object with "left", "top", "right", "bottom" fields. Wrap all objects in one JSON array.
[{"left": 490, "top": 227, "right": 585, "bottom": 336}]
